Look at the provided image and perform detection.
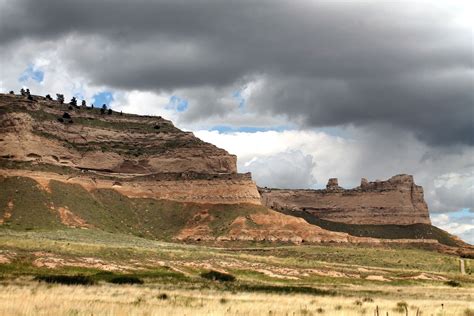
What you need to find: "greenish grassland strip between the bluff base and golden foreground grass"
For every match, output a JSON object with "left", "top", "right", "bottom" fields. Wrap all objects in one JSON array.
[{"left": 0, "top": 228, "right": 474, "bottom": 291}]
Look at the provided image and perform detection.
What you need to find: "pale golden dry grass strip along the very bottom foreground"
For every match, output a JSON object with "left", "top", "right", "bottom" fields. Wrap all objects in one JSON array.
[{"left": 0, "top": 281, "right": 474, "bottom": 316}]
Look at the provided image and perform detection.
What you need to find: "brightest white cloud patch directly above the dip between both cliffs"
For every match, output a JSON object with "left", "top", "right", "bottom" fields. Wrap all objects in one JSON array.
[{"left": 195, "top": 131, "right": 360, "bottom": 188}]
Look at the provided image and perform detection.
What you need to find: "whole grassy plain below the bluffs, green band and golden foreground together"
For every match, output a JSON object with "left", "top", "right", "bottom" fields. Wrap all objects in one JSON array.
[{"left": 0, "top": 229, "right": 474, "bottom": 316}]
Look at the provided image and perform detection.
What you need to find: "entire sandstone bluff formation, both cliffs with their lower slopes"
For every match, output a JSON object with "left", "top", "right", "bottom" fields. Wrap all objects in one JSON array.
[{"left": 0, "top": 94, "right": 466, "bottom": 246}]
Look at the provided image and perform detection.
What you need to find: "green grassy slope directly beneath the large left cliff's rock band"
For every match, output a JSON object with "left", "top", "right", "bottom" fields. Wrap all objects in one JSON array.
[{"left": 0, "top": 177, "right": 266, "bottom": 240}]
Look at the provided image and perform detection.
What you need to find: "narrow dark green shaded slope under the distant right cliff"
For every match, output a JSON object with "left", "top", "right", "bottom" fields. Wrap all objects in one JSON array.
[{"left": 279, "top": 211, "right": 458, "bottom": 246}]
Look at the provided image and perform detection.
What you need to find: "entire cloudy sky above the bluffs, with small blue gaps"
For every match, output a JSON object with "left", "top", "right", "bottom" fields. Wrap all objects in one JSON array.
[{"left": 0, "top": 0, "right": 474, "bottom": 243}]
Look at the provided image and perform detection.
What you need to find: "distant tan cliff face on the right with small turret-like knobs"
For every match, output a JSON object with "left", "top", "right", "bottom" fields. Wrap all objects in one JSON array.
[{"left": 259, "top": 175, "right": 431, "bottom": 225}]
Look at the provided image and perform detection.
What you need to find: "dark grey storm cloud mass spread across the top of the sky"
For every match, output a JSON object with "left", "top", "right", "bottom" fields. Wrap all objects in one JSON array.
[{"left": 0, "top": 0, "right": 474, "bottom": 145}]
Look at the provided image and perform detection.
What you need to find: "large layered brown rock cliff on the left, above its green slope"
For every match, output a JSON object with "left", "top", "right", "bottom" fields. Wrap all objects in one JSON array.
[{"left": 0, "top": 94, "right": 260, "bottom": 204}]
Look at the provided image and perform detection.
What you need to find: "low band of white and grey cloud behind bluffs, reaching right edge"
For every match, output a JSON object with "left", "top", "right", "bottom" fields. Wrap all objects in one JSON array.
[{"left": 195, "top": 128, "right": 474, "bottom": 212}]
